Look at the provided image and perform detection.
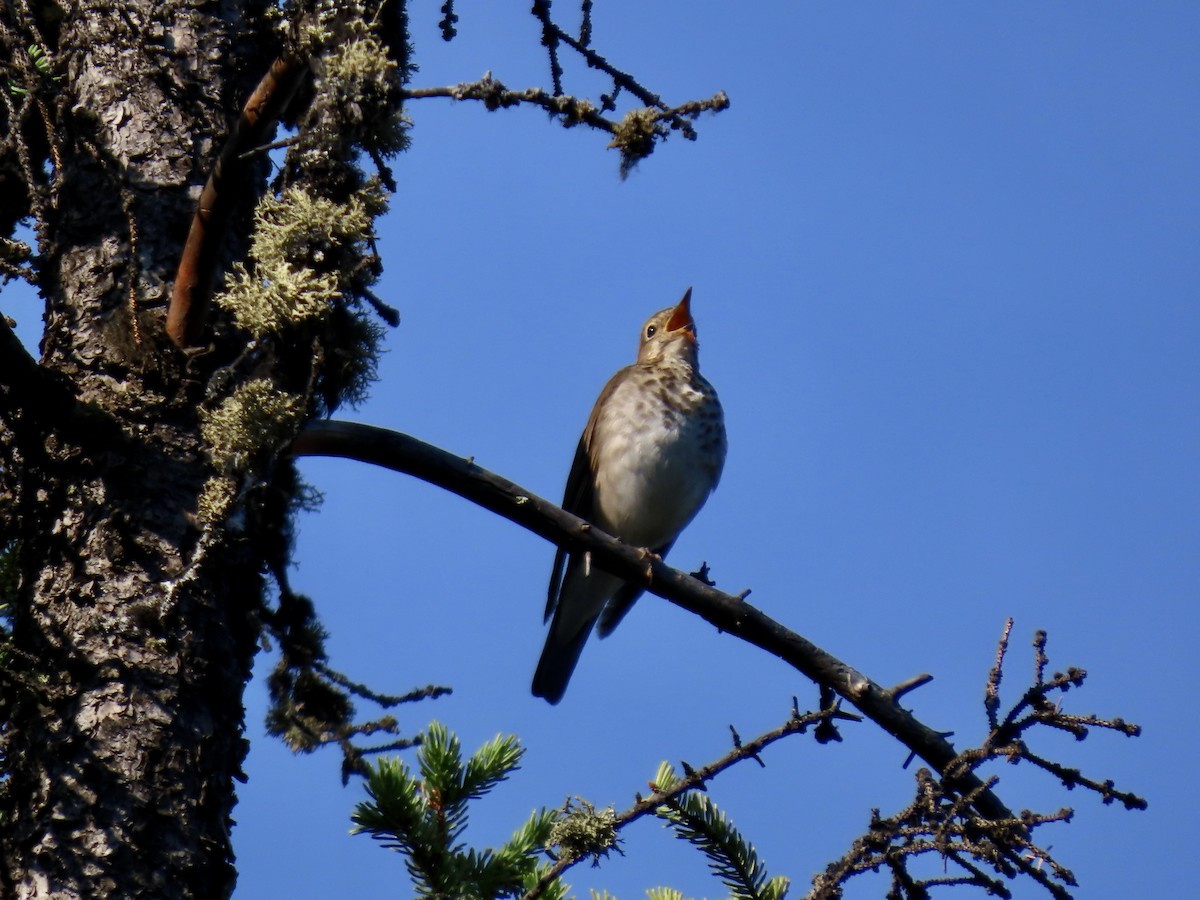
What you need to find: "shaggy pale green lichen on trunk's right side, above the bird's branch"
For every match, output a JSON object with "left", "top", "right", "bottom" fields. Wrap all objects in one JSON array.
[{"left": 224, "top": 0, "right": 409, "bottom": 414}]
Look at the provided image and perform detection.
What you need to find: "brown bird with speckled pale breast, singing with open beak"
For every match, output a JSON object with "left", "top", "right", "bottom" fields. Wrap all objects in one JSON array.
[{"left": 533, "top": 288, "right": 727, "bottom": 703}]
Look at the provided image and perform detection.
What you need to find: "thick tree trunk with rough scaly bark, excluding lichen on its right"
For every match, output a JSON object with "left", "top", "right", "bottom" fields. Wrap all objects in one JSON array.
[{"left": 0, "top": 0, "right": 270, "bottom": 898}]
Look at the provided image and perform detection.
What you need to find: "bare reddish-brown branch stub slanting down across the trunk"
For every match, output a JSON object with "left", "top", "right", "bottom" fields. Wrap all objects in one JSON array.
[{"left": 167, "top": 55, "right": 308, "bottom": 347}]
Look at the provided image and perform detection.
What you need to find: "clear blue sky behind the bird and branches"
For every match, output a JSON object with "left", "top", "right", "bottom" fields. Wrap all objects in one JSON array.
[{"left": 5, "top": 0, "right": 1200, "bottom": 900}]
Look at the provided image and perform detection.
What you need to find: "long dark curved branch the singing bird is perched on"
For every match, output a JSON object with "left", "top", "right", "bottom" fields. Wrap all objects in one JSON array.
[{"left": 289, "top": 421, "right": 1013, "bottom": 818}]
